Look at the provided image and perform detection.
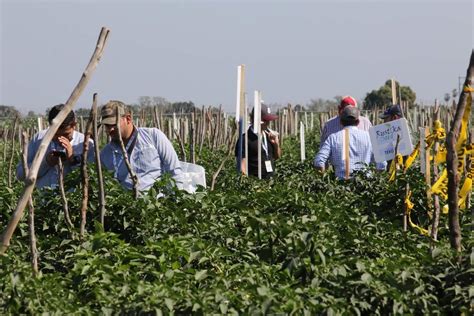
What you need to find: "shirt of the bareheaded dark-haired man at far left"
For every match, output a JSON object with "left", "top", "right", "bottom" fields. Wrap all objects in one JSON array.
[{"left": 16, "top": 129, "right": 94, "bottom": 188}]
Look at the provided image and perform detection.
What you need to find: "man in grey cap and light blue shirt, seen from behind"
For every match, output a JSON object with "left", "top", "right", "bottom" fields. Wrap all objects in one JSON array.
[{"left": 313, "top": 107, "right": 386, "bottom": 179}]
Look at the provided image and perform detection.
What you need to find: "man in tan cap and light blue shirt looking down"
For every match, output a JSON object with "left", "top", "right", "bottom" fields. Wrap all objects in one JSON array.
[{"left": 100, "top": 100, "right": 181, "bottom": 191}]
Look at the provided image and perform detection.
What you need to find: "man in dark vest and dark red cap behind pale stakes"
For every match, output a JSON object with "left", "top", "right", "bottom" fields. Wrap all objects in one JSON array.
[{"left": 235, "top": 104, "right": 281, "bottom": 179}]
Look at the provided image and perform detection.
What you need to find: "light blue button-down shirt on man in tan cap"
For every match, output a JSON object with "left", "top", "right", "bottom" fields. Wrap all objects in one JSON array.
[{"left": 100, "top": 127, "right": 182, "bottom": 191}]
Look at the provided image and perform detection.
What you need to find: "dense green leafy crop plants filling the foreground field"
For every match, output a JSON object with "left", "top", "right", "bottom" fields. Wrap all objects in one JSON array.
[{"left": 0, "top": 131, "right": 473, "bottom": 315}]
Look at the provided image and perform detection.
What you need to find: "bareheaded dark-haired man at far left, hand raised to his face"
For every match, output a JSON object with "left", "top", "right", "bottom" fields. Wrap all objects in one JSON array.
[{"left": 16, "top": 104, "right": 94, "bottom": 188}]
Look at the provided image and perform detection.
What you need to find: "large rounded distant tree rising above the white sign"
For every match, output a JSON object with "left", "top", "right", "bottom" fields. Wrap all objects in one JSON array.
[{"left": 364, "top": 80, "right": 416, "bottom": 109}]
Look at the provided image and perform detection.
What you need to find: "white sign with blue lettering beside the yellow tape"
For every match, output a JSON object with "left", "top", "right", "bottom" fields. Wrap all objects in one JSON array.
[{"left": 369, "top": 118, "right": 413, "bottom": 162}]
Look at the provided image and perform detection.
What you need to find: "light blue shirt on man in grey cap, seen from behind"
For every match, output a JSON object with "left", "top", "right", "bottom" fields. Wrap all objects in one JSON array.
[{"left": 313, "top": 126, "right": 387, "bottom": 179}]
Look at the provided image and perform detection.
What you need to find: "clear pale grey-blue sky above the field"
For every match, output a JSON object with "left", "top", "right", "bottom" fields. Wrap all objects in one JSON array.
[{"left": 0, "top": 0, "right": 474, "bottom": 113}]
